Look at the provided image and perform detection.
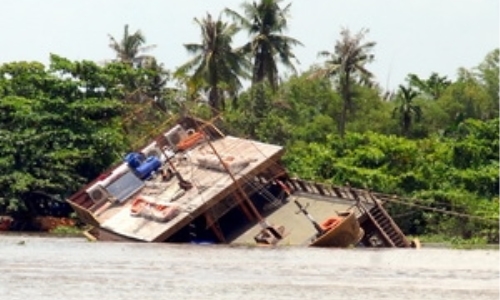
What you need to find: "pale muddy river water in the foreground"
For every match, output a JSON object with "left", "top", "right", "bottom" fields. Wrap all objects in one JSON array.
[{"left": 0, "top": 235, "right": 499, "bottom": 300}]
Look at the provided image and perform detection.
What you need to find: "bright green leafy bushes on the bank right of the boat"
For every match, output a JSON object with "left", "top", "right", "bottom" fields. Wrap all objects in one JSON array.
[{"left": 284, "top": 119, "right": 499, "bottom": 242}]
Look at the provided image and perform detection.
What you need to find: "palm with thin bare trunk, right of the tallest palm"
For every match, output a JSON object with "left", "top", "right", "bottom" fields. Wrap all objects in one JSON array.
[{"left": 313, "top": 29, "right": 376, "bottom": 137}]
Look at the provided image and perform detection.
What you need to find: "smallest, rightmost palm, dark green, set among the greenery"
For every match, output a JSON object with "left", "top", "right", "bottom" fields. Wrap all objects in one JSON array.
[{"left": 392, "top": 85, "right": 422, "bottom": 136}]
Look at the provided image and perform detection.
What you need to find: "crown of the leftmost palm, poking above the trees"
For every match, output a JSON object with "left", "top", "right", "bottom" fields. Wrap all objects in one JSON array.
[{"left": 109, "top": 25, "right": 156, "bottom": 67}]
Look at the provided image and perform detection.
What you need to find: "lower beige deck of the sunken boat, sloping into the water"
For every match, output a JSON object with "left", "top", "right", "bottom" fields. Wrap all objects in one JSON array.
[{"left": 230, "top": 192, "right": 366, "bottom": 246}]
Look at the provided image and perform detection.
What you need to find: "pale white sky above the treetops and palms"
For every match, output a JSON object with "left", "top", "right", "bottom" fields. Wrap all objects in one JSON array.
[{"left": 0, "top": 0, "right": 499, "bottom": 89}]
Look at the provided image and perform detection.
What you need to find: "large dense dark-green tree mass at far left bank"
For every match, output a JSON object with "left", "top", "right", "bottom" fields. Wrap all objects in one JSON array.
[{"left": 0, "top": 56, "right": 125, "bottom": 212}]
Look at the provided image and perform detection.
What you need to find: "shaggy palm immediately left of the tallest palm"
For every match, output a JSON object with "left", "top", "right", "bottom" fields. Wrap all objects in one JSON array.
[{"left": 176, "top": 14, "right": 250, "bottom": 116}]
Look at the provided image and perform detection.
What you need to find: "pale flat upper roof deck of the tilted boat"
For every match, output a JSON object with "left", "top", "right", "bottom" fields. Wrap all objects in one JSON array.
[{"left": 94, "top": 136, "right": 283, "bottom": 242}]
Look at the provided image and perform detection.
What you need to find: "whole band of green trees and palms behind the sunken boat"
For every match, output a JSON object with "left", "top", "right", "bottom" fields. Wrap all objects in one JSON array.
[{"left": 0, "top": 0, "right": 500, "bottom": 244}]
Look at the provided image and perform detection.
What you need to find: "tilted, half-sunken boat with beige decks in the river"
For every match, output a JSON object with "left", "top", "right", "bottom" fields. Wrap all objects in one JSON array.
[{"left": 68, "top": 117, "right": 410, "bottom": 247}]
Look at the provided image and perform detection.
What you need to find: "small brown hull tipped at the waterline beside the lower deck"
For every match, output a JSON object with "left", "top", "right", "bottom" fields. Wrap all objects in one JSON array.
[{"left": 310, "top": 212, "right": 364, "bottom": 248}]
